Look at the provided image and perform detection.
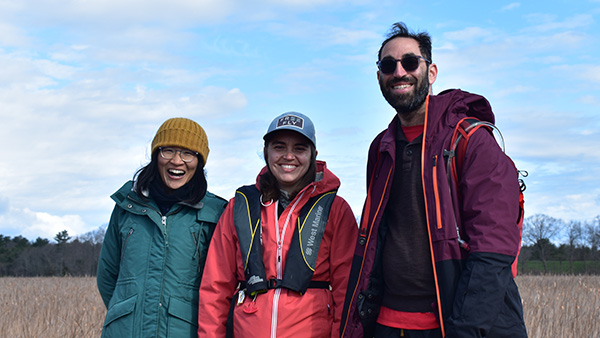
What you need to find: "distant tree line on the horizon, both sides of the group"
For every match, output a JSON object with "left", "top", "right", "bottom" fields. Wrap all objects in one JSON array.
[{"left": 0, "top": 214, "right": 600, "bottom": 277}]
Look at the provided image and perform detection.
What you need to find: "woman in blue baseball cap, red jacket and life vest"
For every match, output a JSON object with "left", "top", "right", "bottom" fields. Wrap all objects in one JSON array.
[{"left": 198, "top": 112, "right": 358, "bottom": 338}]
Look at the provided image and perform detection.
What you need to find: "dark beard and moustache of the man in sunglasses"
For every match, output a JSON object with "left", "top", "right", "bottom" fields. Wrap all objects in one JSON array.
[{"left": 379, "top": 68, "right": 429, "bottom": 116}]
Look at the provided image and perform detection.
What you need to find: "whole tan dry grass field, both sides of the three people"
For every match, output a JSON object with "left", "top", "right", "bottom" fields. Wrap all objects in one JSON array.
[{"left": 0, "top": 276, "right": 600, "bottom": 338}]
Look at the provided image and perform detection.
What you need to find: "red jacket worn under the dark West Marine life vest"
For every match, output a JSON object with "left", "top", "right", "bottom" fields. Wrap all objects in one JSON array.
[{"left": 198, "top": 161, "right": 358, "bottom": 338}]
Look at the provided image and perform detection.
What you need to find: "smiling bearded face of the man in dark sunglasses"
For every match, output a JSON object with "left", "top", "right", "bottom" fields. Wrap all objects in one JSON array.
[{"left": 377, "top": 37, "right": 437, "bottom": 124}]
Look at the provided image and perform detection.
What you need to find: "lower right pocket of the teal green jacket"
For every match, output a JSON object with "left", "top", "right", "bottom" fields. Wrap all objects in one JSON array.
[{"left": 168, "top": 297, "right": 198, "bottom": 337}]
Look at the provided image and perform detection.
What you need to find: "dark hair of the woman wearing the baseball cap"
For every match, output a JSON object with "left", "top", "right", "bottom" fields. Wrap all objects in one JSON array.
[{"left": 258, "top": 138, "right": 317, "bottom": 202}]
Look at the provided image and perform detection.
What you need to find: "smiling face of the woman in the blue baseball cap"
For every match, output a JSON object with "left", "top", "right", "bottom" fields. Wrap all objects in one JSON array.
[{"left": 266, "top": 130, "right": 313, "bottom": 193}]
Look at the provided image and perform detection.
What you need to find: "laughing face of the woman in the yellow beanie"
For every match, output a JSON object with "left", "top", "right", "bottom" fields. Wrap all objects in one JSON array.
[{"left": 157, "top": 147, "right": 198, "bottom": 190}]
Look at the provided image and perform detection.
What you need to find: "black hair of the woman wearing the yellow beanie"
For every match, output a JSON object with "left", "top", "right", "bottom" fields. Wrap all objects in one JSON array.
[{"left": 133, "top": 150, "right": 206, "bottom": 205}]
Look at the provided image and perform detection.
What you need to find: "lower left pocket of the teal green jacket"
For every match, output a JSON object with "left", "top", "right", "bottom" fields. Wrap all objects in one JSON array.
[{"left": 102, "top": 295, "right": 137, "bottom": 337}]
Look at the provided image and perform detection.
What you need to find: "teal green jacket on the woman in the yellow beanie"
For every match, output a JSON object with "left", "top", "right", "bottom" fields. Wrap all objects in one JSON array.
[{"left": 97, "top": 181, "right": 227, "bottom": 338}]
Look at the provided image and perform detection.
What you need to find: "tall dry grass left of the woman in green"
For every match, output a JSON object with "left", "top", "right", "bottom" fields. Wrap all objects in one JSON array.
[{"left": 0, "top": 277, "right": 106, "bottom": 338}]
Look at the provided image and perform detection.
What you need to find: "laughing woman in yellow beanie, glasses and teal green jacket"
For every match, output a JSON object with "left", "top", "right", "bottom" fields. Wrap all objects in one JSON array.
[{"left": 97, "top": 118, "right": 227, "bottom": 337}]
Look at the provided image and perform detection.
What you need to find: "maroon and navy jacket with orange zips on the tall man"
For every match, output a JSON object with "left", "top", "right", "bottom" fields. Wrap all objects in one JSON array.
[{"left": 340, "top": 90, "right": 527, "bottom": 338}]
